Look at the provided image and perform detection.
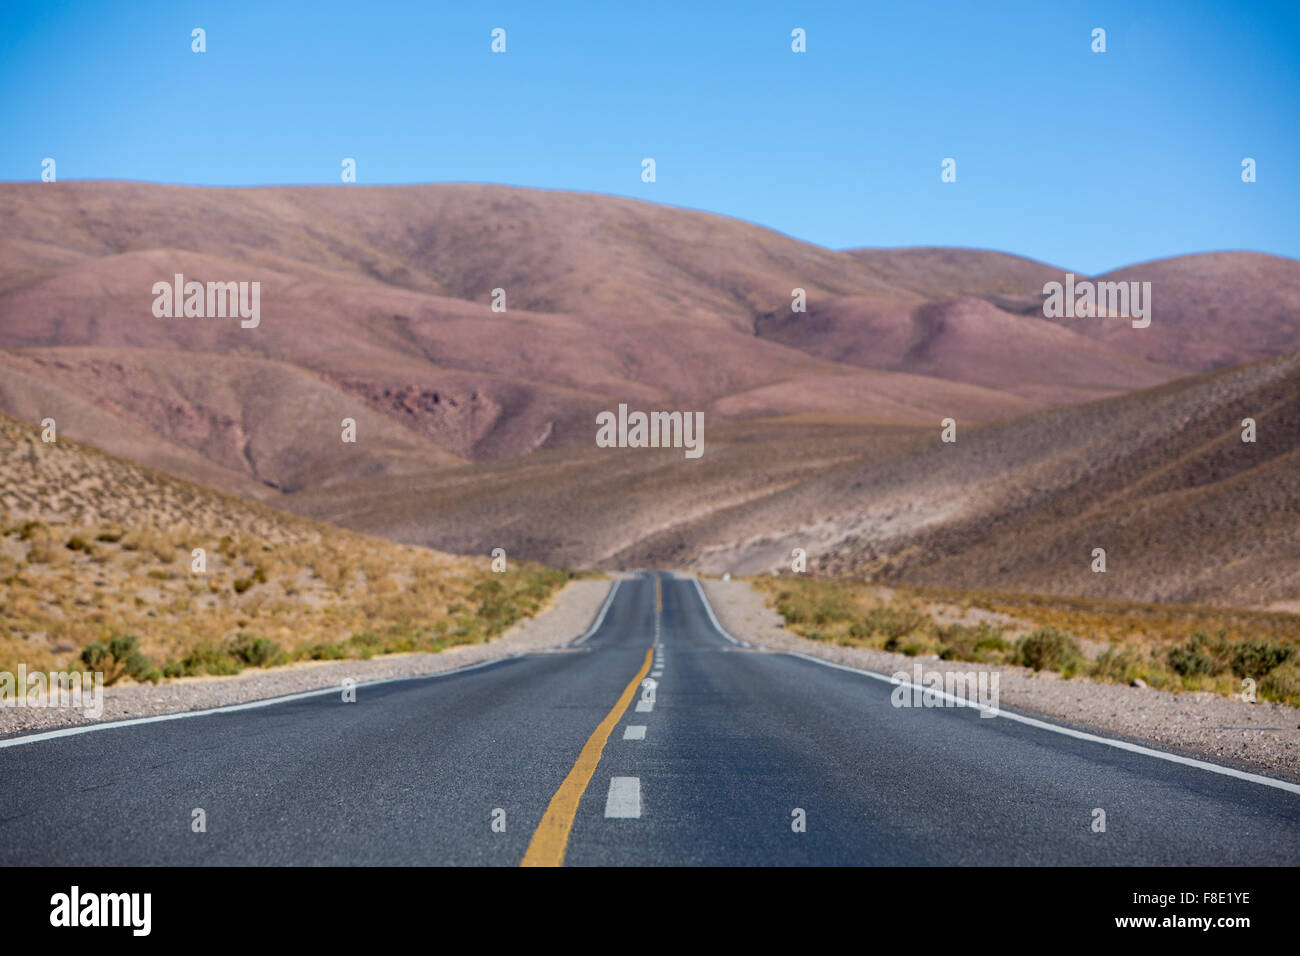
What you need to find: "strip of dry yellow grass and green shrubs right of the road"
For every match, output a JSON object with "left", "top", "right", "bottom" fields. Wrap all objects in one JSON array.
[{"left": 751, "top": 575, "right": 1300, "bottom": 706}]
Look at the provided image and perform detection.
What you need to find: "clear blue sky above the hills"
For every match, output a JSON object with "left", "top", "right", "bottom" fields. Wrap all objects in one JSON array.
[{"left": 0, "top": 0, "right": 1300, "bottom": 273}]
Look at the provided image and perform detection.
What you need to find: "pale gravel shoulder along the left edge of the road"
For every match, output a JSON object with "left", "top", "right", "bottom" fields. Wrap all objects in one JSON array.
[{"left": 0, "top": 579, "right": 614, "bottom": 736}]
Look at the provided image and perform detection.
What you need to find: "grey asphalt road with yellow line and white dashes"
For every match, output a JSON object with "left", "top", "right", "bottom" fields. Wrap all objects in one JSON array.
[{"left": 0, "top": 572, "right": 1300, "bottom": 866}]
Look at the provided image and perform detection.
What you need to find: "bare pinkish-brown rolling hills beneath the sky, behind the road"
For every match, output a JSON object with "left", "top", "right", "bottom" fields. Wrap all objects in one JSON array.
[{"left": 0, "top": 182, "right": 1300, "bottom": 602}]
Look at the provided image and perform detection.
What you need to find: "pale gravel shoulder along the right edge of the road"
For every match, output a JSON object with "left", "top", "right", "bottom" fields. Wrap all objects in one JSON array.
[{"left": 701, "top": 579, "right": 1300, "bottom": 782}]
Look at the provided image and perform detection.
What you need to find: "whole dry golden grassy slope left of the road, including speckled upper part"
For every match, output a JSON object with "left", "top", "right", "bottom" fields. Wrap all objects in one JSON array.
[{"left": 0, "top": 418, "right": 569, "bottom": 679}]
